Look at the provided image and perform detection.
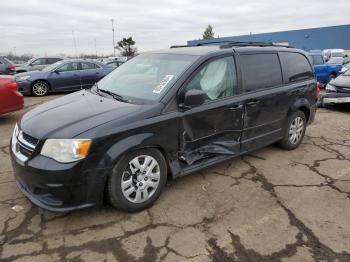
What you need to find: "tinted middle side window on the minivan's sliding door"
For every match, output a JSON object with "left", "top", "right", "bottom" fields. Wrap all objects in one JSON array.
[{"left": 240, "top": 54, "right": 282, "bottom": 92}]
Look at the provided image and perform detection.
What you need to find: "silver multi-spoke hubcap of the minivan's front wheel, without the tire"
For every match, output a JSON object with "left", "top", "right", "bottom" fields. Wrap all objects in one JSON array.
[{"left": 121, "top": 155, "right": 160, "bottom": 203}]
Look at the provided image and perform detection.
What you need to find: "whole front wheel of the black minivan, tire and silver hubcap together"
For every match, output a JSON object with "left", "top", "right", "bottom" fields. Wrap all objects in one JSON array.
[{"left": 107, "top": 148, "right": 167, "bottom": 212}]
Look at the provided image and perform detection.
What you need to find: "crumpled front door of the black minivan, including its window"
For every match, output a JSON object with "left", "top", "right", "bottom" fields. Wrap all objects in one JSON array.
[{"left": 179, "top": 56, "right": 243, "bottom": 165}]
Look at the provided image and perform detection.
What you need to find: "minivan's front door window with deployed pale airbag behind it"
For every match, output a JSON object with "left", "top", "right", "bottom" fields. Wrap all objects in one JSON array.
[{"left": 186, "top": 56, "right": 237, "bottom": 101}]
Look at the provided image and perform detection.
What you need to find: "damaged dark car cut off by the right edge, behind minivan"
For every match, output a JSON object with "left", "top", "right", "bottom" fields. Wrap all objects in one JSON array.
[{"left": 321, "top": 69, "right": 350, "bottom": 106}]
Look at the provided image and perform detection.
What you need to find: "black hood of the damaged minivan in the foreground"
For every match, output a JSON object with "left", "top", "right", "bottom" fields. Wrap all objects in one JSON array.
[{"left": 19, "top": 90, "right": 146, "bottom": 139}]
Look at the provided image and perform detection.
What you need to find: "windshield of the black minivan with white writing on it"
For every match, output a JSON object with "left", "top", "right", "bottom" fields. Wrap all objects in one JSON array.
[{"left": 98, "top": 54, "right": 197, "bottom": 101}]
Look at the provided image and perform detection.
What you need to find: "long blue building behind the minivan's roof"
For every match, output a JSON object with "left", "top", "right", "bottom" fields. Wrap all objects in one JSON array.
[{"left": 187, "top": 24, "right": 350, "bottom": 51}]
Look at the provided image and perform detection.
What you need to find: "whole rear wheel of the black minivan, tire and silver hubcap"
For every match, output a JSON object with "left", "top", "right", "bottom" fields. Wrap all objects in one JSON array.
[{"left": 278, "top": 110, "right": 306, "bottom": 150}]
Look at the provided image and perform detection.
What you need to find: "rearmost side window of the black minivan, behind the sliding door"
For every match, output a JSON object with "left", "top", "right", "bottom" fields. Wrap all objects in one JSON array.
[{"left": 280, "top": 52, "right": 314, "bottom": 83}]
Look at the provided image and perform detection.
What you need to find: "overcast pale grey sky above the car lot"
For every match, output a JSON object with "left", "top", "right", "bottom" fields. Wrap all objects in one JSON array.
[{"left": 0, "top": 0, "right": 350, "bottom": 56}]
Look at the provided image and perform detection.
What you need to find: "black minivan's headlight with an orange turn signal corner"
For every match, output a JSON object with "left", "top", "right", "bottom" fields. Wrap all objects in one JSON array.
[{"left": 40, "top": 139, "right": 91, "bottom": 163}]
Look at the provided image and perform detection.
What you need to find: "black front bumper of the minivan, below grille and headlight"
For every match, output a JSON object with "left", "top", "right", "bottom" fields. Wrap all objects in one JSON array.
[{"left": 10, "top": 134, "right": 106, "bottom": 212}]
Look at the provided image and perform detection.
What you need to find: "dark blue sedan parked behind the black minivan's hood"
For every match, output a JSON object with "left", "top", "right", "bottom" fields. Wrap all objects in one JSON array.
[{"left": 15, "top": 59, "right": 113, "bottom": 96}]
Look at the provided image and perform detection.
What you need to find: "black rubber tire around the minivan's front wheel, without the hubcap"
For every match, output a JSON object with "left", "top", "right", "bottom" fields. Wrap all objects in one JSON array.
[{"left": 108, "top": 148, "right": 167, "bottom": 212}]
